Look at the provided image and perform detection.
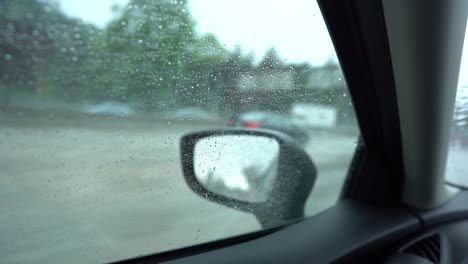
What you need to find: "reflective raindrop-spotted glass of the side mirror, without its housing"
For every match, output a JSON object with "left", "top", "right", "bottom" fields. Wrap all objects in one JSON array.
[{"left": 193, "top": 135, "right": 280, "bottom": 203}]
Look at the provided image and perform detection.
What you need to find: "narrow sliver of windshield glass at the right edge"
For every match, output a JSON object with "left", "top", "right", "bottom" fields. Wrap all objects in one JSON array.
[{"left": 446, "top": 20, "right": 468, "bottom": 187}]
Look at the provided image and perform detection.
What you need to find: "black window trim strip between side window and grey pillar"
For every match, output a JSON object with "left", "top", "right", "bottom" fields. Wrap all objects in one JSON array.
[{"left": 318, "top": 0, "right": 404, "bottom": 205}]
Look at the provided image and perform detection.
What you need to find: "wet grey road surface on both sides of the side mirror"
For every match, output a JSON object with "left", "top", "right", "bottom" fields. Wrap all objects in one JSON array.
[{"left": 0, "top": 114, "right": 355, "bottom": 263}]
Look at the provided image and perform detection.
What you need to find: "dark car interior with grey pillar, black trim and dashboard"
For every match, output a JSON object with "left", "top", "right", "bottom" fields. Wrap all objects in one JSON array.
[{"left": 108, "top": 0, "right": 468, "bottom": 264}]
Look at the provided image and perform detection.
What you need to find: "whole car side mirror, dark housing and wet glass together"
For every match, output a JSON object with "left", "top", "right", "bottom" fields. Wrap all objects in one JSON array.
[{"left": 181, "top": 129, "right": 317, "bottom": 228}]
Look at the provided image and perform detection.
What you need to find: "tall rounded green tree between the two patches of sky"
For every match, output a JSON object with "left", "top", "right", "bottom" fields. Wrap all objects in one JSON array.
[{"left": 100, "top": 0, "right": 195, "bottom": 111}]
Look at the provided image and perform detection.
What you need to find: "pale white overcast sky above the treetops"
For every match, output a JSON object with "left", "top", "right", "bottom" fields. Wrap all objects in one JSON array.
[{"left": 57, "top": 0, "right": 468, "bottom": 85}]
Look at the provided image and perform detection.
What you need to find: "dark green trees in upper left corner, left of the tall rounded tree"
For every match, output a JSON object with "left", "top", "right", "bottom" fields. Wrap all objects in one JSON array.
[{"left": 0, "top": 0, "right": 98, "bottom": 104}]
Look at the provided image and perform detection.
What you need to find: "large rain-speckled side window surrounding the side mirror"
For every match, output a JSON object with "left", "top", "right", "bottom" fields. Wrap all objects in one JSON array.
[{"left": 0, "top": 0, "right": 358, "bottom": 263}]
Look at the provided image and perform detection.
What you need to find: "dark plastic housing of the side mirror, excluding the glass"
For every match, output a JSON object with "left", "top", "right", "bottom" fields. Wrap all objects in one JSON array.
[{"left": 181, "top": 129, "right": 317, "bottom": 228}]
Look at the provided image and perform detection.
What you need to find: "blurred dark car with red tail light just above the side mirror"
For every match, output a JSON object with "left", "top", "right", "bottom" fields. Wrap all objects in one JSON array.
[{"left": 227, "top": 111, "right": 309, "bottom": 145}]
